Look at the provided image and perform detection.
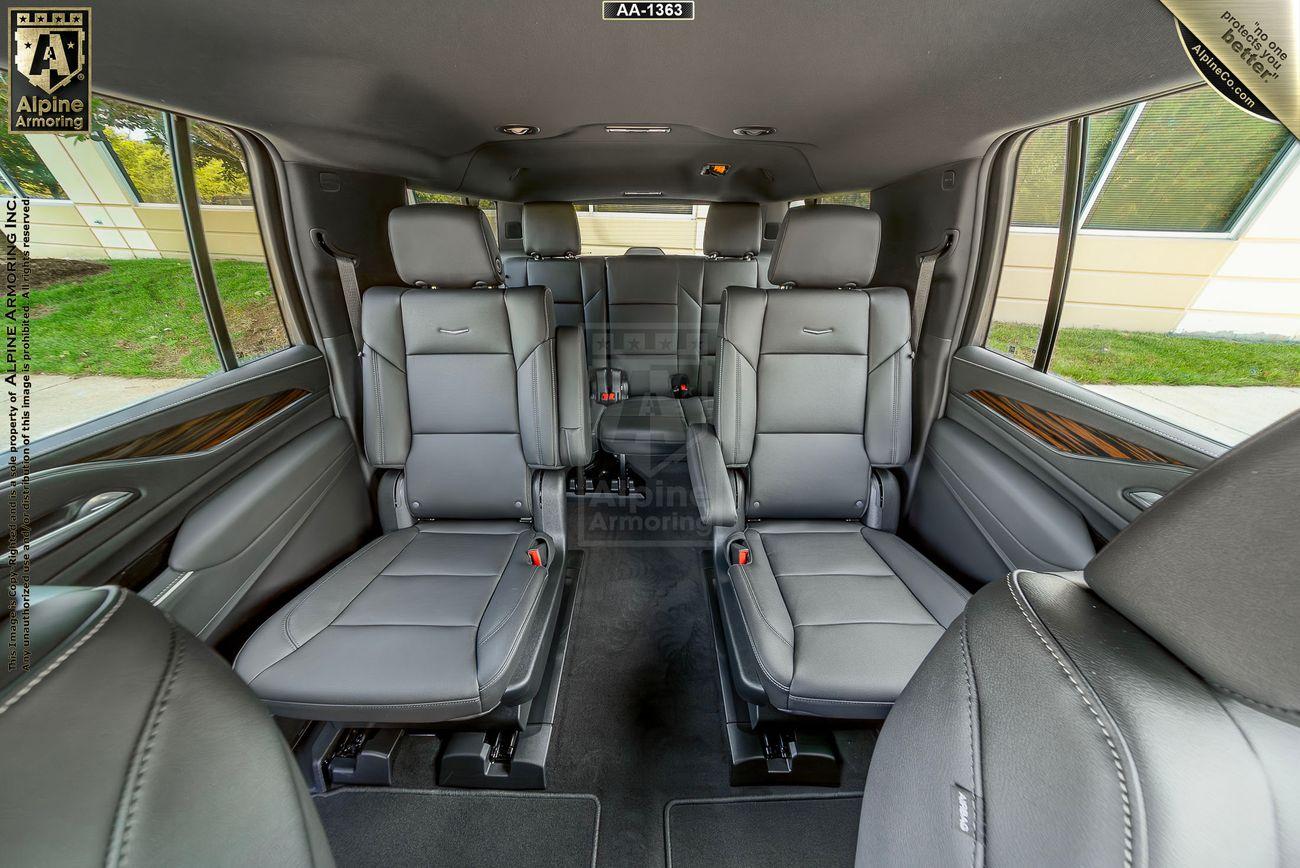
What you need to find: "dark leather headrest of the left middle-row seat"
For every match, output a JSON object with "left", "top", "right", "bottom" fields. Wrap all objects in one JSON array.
[{"left": 389, "top": 203, "right": 503, "bottom": 288}]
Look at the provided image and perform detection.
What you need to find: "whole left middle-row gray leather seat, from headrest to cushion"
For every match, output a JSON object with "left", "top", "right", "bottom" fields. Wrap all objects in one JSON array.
[{"left": 235, "top": 204, "right": 590, "bottom": 722}]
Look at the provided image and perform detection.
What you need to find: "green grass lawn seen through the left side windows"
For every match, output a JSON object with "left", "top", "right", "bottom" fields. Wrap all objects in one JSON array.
[{"left": 31, "top": 259, "right": 289, "bottom": 377}]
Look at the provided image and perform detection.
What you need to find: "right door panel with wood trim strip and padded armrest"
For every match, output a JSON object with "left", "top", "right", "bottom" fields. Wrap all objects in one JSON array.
[{"left": 910, "top": 347, "right": 1225, "bottom": 581}]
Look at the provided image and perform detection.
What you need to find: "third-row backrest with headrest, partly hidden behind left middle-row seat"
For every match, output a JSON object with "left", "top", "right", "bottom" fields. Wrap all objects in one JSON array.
[{"left": 504, "top": 201, "right": 606, "bottom": 368}]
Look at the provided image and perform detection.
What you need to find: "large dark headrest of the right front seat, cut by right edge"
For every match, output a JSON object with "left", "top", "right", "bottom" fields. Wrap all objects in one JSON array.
[{"left": 1084, "top": 413, "right": 1300, "bottom": 715}]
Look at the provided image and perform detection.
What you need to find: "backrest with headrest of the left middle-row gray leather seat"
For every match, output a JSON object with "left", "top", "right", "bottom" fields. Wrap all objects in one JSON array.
[{"left": 361, "top": 204, "right": 560, "bottom": 518}]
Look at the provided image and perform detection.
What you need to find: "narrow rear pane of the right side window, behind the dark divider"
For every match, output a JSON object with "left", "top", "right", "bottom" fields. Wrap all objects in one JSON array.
[{"left": 984, "top": 123, "right": 1066, "bottom": 365}]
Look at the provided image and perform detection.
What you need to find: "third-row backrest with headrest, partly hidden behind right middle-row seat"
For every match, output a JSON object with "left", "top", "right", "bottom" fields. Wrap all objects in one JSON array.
[{"left": 692, "top": 201, "right": 768, "bottom": 395}]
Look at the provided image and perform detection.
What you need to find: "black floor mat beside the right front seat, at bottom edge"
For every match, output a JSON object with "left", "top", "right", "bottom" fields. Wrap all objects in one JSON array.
[{"left": 663, "top": 794, "right": 862, "bottom": 868}]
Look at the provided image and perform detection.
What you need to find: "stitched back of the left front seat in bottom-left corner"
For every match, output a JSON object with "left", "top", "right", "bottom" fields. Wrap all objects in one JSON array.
[{"left": 0, "top": 586, "right": 334, "bottom": 865}]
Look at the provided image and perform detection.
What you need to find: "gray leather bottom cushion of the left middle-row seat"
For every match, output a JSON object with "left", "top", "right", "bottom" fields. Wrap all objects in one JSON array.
[{"left": 235, "top": 521, "right": 547, "bottom": 722}]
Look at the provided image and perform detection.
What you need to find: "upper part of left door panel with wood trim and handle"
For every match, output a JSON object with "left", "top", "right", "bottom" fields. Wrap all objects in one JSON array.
[{"left": 19, "top": 347, "right": 368, "bottom": 600}]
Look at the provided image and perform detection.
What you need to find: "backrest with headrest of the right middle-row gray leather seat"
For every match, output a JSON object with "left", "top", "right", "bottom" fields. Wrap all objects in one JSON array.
[{"left": 715, "top": 205, "right": 911, "bottom": 518}]
